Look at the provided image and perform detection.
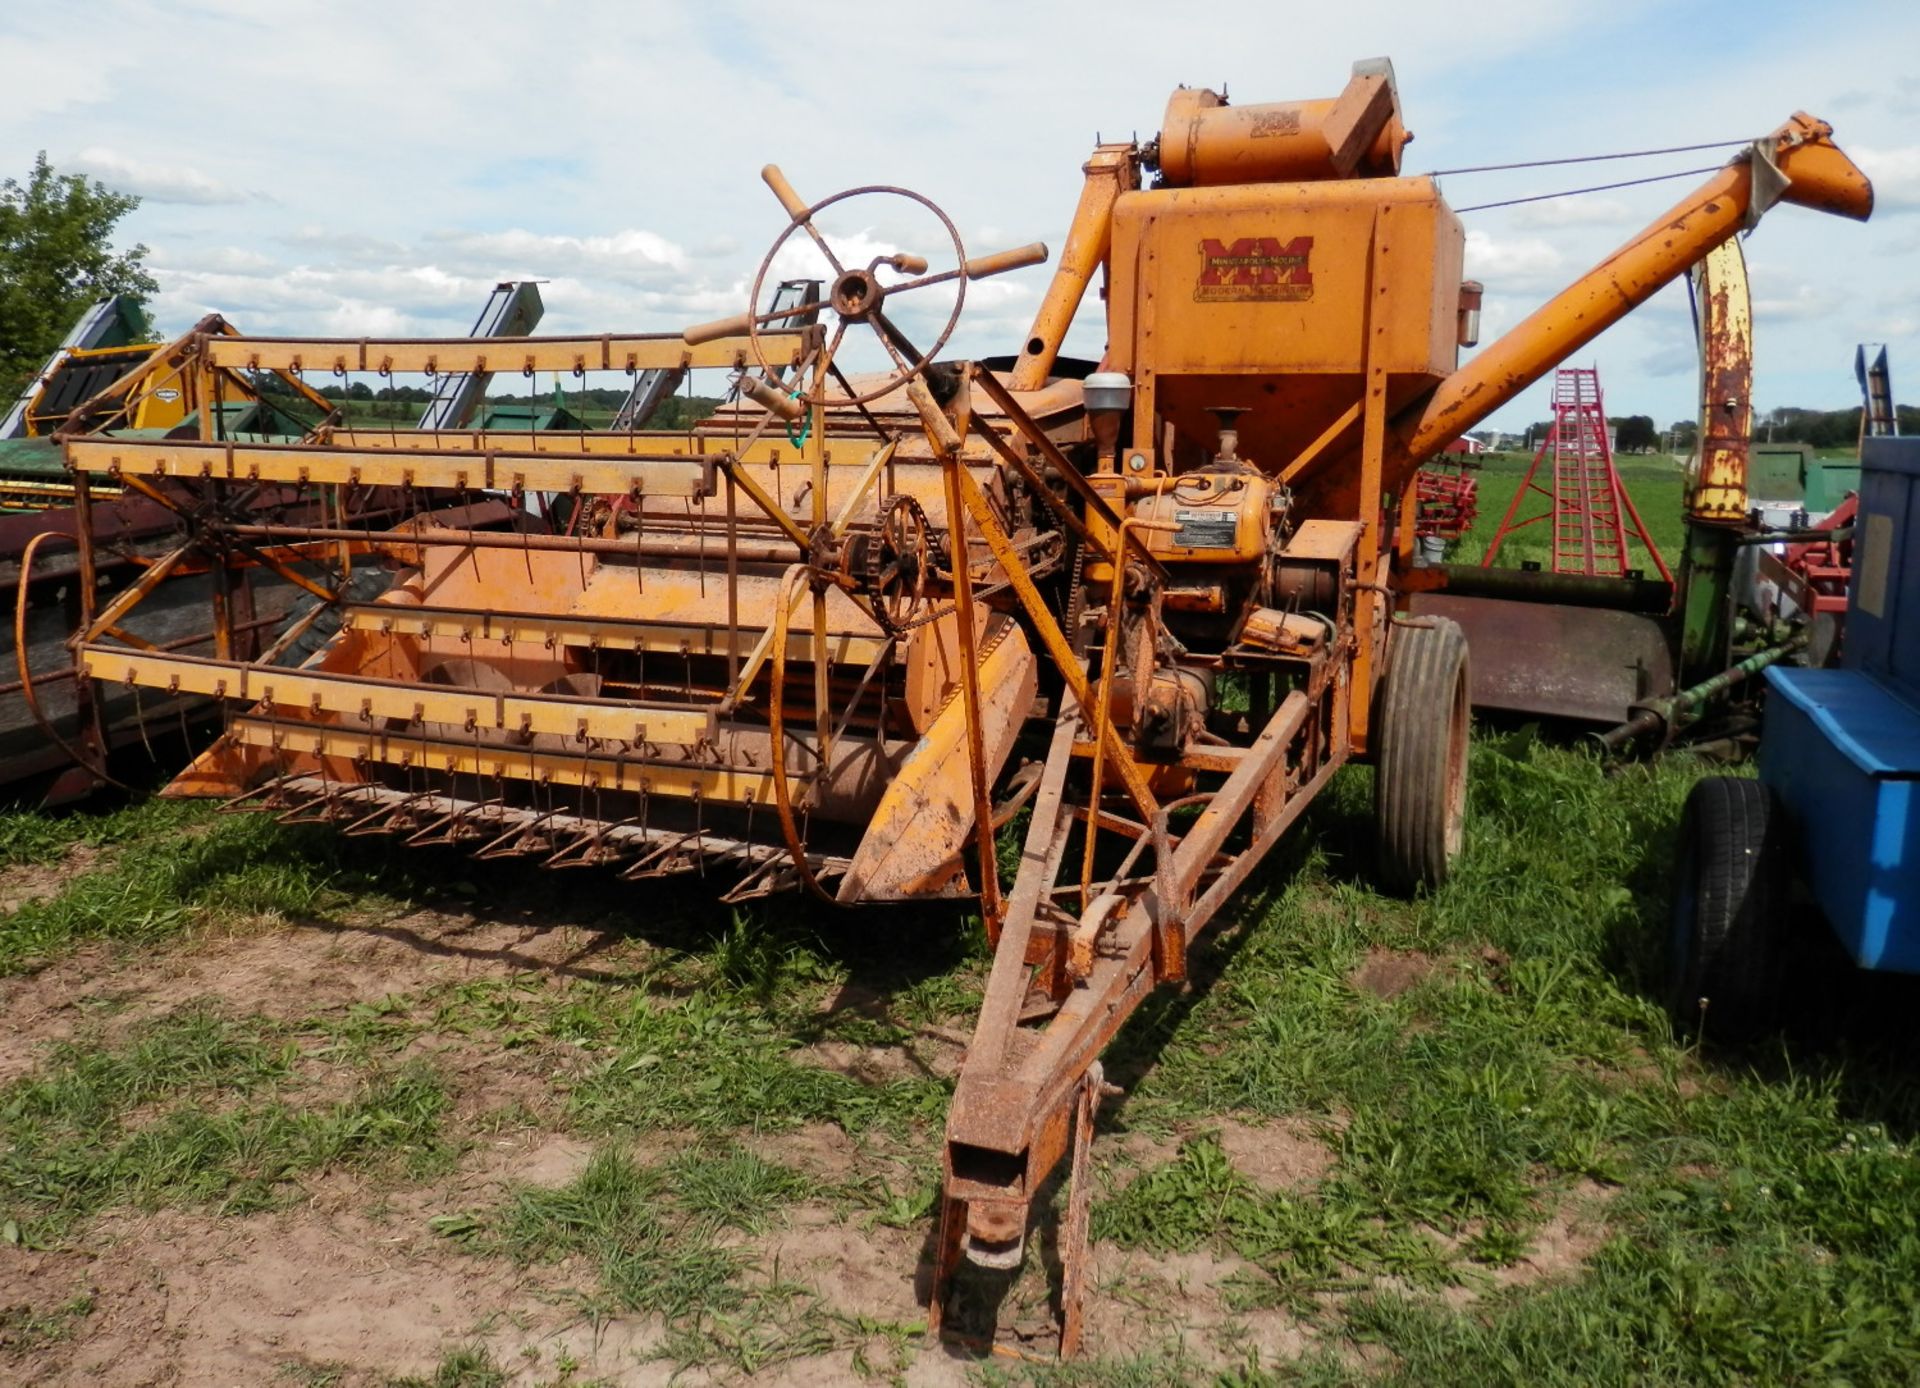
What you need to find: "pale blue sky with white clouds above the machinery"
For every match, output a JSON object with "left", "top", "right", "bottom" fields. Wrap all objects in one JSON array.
[{"left": 0, "top": 0, "right": 1920, "bottom": 430}]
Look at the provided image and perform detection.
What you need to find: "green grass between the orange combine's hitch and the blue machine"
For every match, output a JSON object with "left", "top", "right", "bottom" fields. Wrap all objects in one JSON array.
[{"left": 1006, "top": 737, "right": 1920, "bottom": 1384}]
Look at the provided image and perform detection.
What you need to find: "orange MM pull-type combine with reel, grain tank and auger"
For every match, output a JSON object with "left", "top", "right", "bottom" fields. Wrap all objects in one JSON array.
[{"left": 67, "top": 61, "right": 1872, "bottom": 1353}]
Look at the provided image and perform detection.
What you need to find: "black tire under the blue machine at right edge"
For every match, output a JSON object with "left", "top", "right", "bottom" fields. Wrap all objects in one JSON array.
[{"left": 1667, "top": 776, "right": 1793, "bottom": 1041}]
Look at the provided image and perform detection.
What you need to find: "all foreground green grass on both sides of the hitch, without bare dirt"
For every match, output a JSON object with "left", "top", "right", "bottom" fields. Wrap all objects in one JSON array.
[{"left": 0, "top": 731, "right": 1920, "bottom": 1384}]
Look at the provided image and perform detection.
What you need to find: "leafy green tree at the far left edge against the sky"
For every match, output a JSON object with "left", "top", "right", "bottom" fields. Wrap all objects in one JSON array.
[{"left": 0, "top": 150, "right": 159, "bottom": 397}]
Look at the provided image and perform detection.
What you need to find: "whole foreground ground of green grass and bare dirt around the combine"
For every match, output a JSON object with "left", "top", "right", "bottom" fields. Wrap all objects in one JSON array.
[{"left": 0, "top": 465, "right": 1920, "bottom": 1388}]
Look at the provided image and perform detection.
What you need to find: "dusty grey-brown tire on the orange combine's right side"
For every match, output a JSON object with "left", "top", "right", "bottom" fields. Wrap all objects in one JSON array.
[{"left": 1373, "top": 616, "right": 1473, "bottom": 893}]
